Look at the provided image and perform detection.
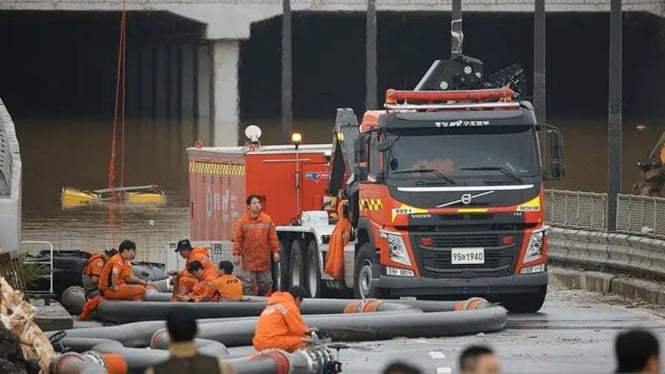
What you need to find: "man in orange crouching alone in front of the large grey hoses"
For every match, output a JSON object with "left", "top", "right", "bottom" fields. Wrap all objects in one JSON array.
[{"left": 252, "top": 285, "right": 317, "bottom": 352}]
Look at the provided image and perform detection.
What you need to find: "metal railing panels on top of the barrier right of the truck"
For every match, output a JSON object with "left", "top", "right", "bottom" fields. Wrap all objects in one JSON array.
[{"left": 545, "top": 189, "right": 665, "bottom": 238}]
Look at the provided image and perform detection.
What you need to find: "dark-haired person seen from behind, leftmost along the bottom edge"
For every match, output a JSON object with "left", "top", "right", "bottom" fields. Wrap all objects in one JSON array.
[{"left": 145, "top": 305, "right": 234, "bottom": 374}]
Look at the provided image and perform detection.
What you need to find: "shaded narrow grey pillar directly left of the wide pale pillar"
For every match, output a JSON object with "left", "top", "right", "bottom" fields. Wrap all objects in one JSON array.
[{"left": 194, "top": 44, "right": 212, "bottom": 145}]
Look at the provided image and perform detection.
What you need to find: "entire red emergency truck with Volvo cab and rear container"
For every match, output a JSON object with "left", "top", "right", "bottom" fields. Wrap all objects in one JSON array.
[{"left": 187, "top": 56, "right": 564, "bottom": 312}]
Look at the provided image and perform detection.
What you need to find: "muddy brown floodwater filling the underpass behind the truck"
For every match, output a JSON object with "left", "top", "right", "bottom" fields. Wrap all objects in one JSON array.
[{"left": 15, "top": 116, "right": 665, "bottom": 262}]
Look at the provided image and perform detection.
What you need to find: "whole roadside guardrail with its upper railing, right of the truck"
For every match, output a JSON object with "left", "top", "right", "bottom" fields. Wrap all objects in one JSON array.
[{"left": 545, "top": 190, "right": 665, "bottom": 279}]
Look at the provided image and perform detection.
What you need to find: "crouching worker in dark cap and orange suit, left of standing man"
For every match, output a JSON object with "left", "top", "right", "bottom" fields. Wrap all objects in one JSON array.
[{"left": 168, "top": 239, "right": 217, "bottom": 300}]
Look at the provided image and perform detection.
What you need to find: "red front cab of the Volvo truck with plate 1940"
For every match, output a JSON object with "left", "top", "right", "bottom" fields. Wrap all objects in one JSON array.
[{"left": 342, "top": 91, "right": 564, "bottom": 311}]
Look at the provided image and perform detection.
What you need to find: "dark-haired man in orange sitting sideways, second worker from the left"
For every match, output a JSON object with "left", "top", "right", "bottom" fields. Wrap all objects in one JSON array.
[{"left": 99, "top": 240, "right": 150, "bottom": 300}]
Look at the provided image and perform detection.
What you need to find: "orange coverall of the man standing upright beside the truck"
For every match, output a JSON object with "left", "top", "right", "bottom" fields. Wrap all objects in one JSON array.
[{"left": 233, "top": 212, "right": 279, "bottom": 272}]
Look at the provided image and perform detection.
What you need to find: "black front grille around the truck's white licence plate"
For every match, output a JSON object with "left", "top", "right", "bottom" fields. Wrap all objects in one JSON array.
[{"left": 411, "top": 232, "right": 523, "bottom": 278}]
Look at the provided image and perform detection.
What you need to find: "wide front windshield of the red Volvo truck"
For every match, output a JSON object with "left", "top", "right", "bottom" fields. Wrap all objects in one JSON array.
[{"left": 385, "top": 126, "right": 540, "bottom": 184}]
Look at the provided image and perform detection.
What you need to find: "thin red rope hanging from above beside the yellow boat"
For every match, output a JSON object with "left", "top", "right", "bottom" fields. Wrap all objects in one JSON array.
[{"left": 108, "top": 0, "right": 127, "bottom": 248}]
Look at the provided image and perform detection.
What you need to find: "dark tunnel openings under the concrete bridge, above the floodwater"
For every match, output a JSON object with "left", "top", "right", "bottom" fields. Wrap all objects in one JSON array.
[{"left": 0, "top": 11, "right": 665, "bottom": 118}]
